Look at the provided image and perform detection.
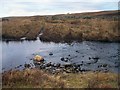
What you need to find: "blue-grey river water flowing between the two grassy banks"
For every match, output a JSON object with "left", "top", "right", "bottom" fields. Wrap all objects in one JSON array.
[{"left": 0, "top": 40, "right": 120, "bottom": 72}]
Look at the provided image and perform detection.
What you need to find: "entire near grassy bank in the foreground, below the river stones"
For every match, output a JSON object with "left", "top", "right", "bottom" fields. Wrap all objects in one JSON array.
[{"left": 2, "top": 69, "right": 118, "bottom": 88}]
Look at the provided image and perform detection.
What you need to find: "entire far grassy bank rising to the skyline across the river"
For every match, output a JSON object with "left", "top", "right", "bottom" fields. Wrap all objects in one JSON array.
[{"left": 2, "top": 11, "right": 120, "bottom": 42}]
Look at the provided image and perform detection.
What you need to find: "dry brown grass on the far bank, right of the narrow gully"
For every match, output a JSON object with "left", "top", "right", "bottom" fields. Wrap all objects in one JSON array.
[{"left": 41, "top": 19, "right": 120, "bottom": 41}]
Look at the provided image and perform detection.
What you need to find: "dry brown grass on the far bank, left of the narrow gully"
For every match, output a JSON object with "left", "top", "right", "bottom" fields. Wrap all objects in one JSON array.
[{"left": 2, "top": 18, "right": 44, "bottom": 39}]
